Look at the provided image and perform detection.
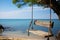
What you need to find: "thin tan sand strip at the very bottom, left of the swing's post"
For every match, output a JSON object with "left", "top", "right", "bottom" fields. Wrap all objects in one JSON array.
[{"left": 0, "top": 36, "right": 42, "bottom": 40}]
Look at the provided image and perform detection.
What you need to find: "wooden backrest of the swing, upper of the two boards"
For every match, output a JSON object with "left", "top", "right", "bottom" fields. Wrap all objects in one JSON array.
[{"left": 34, "top": 20, "right": 54, "bottom": 28}]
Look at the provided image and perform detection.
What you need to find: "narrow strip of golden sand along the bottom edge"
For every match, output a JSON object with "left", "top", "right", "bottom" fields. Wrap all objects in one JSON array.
[{"left": 0, "top": 36, "right": 55, "bottom": 40}]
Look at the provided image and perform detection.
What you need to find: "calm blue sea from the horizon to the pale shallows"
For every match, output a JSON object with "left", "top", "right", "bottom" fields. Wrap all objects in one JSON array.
[{"left": 0, "top": 19, "right": 60, "bottom": 35}]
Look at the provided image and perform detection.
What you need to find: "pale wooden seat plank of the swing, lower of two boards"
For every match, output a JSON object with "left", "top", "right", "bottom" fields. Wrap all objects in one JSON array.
[{"left": 29, "top": 30, "right": 53, "bottom": 38}]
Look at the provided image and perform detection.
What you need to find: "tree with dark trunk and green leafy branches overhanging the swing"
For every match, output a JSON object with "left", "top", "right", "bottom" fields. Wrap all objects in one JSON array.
[{"left": 12, "top": 0, "right": 60, "bottom": 19}]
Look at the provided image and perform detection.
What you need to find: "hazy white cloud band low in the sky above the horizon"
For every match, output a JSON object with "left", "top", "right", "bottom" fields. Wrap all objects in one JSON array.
[{"left": 0, "top": 7, "right": 57, "bottom": 19}]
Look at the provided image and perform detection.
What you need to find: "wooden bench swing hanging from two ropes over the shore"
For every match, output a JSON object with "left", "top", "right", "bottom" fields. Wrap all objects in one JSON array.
[{"left": 28, "top": 0, "right": 54, "bottom": 39}]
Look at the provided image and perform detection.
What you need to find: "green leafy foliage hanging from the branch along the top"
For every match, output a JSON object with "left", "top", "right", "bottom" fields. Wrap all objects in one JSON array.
[{"left": 12, "top": 0, "right": 47, "bottom": 8}]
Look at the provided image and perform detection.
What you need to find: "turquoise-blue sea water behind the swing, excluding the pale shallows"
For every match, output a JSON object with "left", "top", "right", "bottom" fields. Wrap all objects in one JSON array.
[{"left": 0, "top": 19, "right": 60, "bottom": 34}]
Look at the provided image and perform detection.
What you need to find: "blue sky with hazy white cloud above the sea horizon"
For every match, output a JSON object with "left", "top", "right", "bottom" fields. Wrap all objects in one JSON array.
[{"left": 0, "top": 0, "right": 58, "bottom": 19}]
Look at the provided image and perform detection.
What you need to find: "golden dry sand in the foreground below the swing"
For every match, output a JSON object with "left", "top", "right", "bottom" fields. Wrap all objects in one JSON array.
[{"left": 0, "top": 36, "right": 43, "bottom": 40}]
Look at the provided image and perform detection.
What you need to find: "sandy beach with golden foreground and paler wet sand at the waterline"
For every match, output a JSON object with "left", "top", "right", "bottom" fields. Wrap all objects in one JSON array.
[{"left": 0, "top": 32, "right": 55, "bottom": 40}]
